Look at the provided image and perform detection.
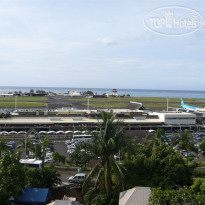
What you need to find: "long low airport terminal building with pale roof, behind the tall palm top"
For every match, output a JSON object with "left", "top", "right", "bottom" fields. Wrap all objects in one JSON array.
[{"left": 0, "top": 108, "right": 201, "bottom": 131}]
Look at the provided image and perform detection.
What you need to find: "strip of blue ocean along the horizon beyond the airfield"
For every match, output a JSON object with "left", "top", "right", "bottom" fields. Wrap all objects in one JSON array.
[{"left": 0, "top": 86, "right": 205, "bottom": 98}]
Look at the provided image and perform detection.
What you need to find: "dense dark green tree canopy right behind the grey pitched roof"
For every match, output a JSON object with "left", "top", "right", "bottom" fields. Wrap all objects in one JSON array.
[{"left": 124, "top": 141, "right": 192, "bottom": 189}]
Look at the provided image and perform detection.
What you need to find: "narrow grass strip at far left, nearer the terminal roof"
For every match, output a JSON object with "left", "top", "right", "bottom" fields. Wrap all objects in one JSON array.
[{"left": 0, "top": 102, "right": 47, "bottom": 108}]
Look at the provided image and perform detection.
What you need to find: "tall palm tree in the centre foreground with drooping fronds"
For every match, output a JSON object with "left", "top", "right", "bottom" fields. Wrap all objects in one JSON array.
[{"left": 82, "top": 111, "right": 124, "bottom": 197}]
